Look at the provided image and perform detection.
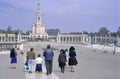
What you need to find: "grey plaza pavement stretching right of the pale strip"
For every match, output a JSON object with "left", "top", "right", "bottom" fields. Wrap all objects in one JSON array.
[{"left": 24, "top": 42, "right": 120, "bottom": 79}]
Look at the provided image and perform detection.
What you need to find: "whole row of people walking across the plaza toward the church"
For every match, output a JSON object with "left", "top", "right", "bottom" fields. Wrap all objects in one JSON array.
[{"left": 10, "top": 45, "right": 77, "bottom": 75}]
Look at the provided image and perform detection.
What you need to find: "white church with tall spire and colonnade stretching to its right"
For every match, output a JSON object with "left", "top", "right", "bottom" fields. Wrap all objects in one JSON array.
[{"left": 22, "top": 3, "right": 114, "bottom": 44}]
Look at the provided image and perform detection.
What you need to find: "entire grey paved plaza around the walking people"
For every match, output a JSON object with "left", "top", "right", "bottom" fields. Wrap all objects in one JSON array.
[{"left": 0, "top": 42, "right": 120, "bottom": 79}]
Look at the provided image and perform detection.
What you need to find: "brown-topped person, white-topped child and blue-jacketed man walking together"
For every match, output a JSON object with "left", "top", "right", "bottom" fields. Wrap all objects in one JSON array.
[{"left": 26, "top": 45, "right": 54, "bottom": 75}]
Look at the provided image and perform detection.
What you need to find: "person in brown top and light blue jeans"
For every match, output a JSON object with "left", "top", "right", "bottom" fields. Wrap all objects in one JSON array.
[{"left": 27, "top": 48, "right": 35, "bottom": 73}]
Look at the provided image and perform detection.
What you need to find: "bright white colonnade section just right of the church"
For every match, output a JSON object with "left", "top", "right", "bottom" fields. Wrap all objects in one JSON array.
[{"left": 57, "top": 33, "right": 90, "bottom": 44}]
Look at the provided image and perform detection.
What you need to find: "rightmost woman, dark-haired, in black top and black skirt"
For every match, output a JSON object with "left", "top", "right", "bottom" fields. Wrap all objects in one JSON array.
[{"left": 68, "top": 46, "right": 78, "bottom": 72}]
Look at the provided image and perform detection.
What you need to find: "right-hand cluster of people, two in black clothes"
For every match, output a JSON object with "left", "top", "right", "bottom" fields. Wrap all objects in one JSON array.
[{"left": 58, "top": 46, "right": 78, "bottom": 73}]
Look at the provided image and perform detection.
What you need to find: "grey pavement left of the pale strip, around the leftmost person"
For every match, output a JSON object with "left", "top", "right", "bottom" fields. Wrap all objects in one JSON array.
[{"left": 0, "top": 54, "right": 26, "bottom": 79}]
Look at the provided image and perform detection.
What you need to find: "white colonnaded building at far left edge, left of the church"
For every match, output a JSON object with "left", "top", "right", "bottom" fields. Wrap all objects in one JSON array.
[{"left": 0, "top": 33, "right": 22, "bottom": 50}]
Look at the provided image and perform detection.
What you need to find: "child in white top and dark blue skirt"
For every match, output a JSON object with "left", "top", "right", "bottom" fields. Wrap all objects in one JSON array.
[{"left": 35, "top": 54, "right": 43, "bottom": 73}]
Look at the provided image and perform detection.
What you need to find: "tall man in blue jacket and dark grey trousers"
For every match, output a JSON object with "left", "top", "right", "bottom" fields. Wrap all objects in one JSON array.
[{"left": 43, "top": 45, "right": 54, "bottom": 75}]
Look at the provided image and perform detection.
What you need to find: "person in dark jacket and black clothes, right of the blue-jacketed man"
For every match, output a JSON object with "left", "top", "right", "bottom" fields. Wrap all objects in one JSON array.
[{"left": 58, "top": 49, "right": 67, "bottom": 73}]
